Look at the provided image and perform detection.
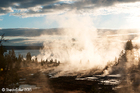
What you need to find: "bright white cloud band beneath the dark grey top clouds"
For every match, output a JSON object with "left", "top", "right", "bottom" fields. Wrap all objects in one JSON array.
[{"left": 11, "top": 2, "right": 140, "bottom": 18}]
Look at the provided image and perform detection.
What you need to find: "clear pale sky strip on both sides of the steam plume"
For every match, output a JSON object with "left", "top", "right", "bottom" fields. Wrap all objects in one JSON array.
[{"left": 0, "top": 14, "right": 127, "bottom": 29}]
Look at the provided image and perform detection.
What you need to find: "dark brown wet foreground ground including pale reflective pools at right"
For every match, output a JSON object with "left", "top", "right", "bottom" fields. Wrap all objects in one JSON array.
[{"left": 16, "top": 68, "right": 120, "bottom": 93}]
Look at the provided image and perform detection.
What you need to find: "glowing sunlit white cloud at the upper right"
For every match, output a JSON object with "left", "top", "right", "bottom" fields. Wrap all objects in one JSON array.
[{"left": 79, "top": 2, "right": 140, "bottom": 16}]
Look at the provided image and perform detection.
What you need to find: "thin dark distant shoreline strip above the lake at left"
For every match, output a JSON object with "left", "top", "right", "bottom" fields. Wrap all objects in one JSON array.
[{"left": 4, "top": 46, "right": 43, "bottom": 50}]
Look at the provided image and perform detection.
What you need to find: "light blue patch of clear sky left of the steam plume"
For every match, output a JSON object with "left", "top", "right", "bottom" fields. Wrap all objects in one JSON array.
[{"left": 0, "top": 14, "right": 55, "bottom": 29}]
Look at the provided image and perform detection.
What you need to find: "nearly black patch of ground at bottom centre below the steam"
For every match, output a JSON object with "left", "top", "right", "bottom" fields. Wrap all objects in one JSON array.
[{"left": 49, "top": 76, "right": 115, "bottom": 93}]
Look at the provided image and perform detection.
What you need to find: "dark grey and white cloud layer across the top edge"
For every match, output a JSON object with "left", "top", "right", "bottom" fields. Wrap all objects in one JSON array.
[{"left": 0, "top": 0, "right": 140, "bottom": 17}]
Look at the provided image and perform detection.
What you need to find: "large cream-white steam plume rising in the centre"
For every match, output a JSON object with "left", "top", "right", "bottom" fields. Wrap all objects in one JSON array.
[{"left": 38, "top": 15, "right": 124, "bottom": 74}]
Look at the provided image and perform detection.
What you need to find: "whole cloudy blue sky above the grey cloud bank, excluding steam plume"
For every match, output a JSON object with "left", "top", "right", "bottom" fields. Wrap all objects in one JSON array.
[{"left": 0, "top": 0, "right": 140, "bottom": 29}]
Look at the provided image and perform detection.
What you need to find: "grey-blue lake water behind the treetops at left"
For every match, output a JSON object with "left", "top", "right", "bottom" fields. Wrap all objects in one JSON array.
[{"left": 7, "top": 50, "right": 40, "bottom": 58}]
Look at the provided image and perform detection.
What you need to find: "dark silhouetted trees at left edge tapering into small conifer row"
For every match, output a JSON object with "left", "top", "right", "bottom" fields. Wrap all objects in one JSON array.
[{"left": 0, "top": 34, "right": 60, "bottom": 91}]
